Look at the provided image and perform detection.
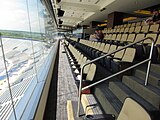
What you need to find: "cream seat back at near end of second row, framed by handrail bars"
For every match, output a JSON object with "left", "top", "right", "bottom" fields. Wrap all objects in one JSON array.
[{"left": 122, "top": 48, "right": 136, "bottom": 63}]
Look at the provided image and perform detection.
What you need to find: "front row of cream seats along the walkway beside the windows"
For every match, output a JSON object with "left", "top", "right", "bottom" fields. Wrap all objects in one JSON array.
[{"left": 65, "top": 41, "right": 97, "bottom": 88}]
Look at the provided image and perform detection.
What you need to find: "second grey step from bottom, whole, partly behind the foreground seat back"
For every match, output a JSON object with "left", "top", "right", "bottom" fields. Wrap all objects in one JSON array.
[{"left": 109, "top": 82, "right": 157, "bottom": 111}]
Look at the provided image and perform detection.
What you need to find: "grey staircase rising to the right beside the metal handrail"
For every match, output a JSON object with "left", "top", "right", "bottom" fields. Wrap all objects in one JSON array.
[{"left": 94, "top": 64, "right": 160, "bottom": 120}]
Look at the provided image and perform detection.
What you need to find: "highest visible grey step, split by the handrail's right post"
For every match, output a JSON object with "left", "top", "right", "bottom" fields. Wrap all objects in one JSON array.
[{"left": 134, "top": 67, "right": 160, "bottom": 88}]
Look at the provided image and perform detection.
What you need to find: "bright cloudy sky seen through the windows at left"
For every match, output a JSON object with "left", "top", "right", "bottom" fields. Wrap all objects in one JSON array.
[{"left": 0, "top": 0, "right": 44, "bottom": 32}]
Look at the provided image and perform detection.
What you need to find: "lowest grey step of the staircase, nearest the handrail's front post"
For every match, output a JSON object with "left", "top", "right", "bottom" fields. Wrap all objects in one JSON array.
[{"left": 94, "top": 84, "right": 122, "bottom": 116}]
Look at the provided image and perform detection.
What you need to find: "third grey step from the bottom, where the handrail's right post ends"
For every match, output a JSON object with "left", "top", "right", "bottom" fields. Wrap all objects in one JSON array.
[{"left": 122, "top": 76, "right": 160, "bottom": 109}]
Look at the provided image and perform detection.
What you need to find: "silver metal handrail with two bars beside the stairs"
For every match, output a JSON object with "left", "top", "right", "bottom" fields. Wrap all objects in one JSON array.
[{"left": 77, "top": 37, "right": 154, "bottom": 117}]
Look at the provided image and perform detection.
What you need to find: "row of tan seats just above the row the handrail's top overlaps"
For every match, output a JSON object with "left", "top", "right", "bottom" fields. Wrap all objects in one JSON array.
[{"left": 103, "top": 24, "right": 160, "bottom": 34}]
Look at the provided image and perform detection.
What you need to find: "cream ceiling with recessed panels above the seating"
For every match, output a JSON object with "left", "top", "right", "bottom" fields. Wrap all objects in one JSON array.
[{"left": 53, "top": 0, "right": 160, "bottom": 26}]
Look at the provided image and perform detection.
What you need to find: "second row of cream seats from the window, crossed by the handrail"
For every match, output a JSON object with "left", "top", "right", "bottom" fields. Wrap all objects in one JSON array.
[{"left": 77, "top": 40, "right": 136, "bottom": 72}]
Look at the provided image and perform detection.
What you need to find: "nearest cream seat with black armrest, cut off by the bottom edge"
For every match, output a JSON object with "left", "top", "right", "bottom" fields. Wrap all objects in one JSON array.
[{"left": 84, "top": 97, "right": 152, "bottom": 120}]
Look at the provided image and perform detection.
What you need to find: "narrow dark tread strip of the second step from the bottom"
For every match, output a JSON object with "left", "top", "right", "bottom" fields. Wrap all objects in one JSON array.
[{"left": 114, "top": 82, "right": 157, "bottom": 111}]
